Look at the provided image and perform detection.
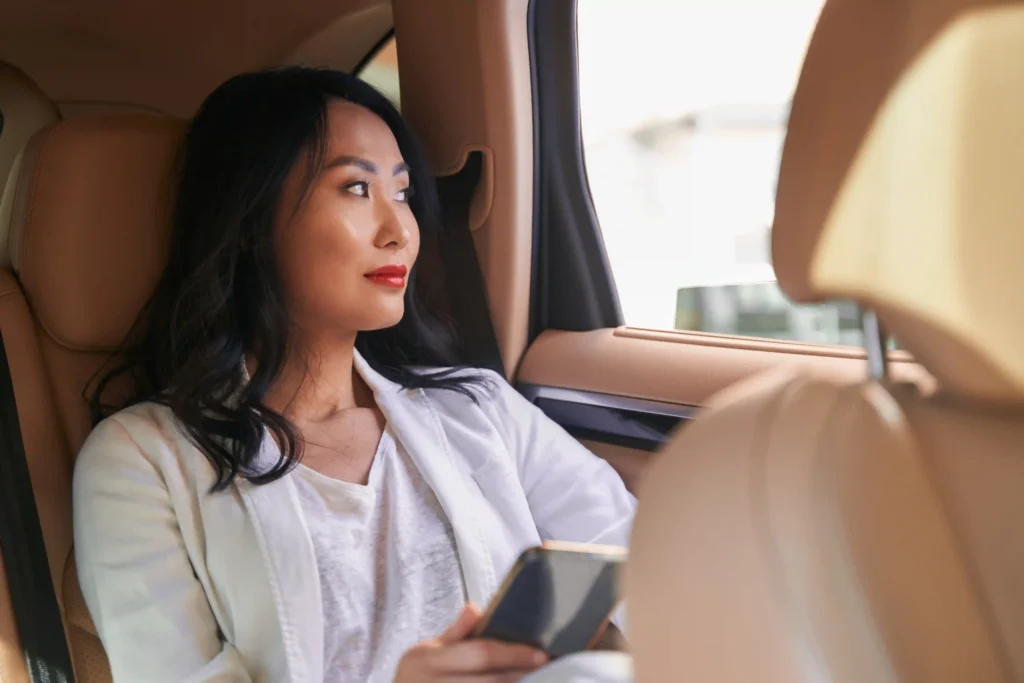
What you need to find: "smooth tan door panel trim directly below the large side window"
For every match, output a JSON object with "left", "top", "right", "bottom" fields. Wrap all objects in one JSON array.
[{"left": 517, "top": 329, "right": 934, "bottom": 405}]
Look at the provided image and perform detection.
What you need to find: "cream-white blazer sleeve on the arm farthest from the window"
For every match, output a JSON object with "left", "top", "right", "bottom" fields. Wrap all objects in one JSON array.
[{"left": 73, "top": 418, "right": 250, "bottom": 683}]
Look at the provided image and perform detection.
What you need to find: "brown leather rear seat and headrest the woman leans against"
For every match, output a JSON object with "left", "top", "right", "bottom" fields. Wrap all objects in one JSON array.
[{"left": 0, "top": 116, "right": 183, "bottom": 683}]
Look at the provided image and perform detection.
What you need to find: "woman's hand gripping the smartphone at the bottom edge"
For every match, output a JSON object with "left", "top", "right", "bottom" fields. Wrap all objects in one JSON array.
[{"left": 394, "top": 605, "right": 548, "bottom": 683}]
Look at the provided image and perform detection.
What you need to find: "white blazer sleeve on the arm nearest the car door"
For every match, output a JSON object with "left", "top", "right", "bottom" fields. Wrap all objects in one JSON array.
[{"left": 489, "top": 380, "right": 636, "bottom": 546}]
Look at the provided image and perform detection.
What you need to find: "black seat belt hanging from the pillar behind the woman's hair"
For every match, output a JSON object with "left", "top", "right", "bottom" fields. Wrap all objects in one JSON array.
[{"left": 437, "top": 152, "right": 505, "bottom": 377}]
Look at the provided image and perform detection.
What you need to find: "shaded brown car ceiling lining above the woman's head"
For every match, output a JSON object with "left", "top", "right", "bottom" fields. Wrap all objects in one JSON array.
[{"left": 0, "top": 0, "right": 392, "bottom": 118}]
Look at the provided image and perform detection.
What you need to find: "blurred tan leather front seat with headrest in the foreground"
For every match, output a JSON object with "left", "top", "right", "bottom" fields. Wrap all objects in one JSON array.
[{"left": 626, "top": 0, "right": 1024, "bottom": 683}]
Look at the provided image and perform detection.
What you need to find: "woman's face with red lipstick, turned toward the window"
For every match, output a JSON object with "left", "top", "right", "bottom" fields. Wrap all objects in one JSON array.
[{"left": 274, "top": 100, "right": 420, "bottom": 335}]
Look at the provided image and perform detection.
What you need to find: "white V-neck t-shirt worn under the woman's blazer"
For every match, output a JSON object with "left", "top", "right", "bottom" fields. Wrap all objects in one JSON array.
[{"left": 288, "top": 429, "right": 466, "bottom": 683}]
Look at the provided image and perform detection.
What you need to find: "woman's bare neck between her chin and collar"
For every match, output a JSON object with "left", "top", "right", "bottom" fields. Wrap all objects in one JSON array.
[{"left": 265, "top": 335, "right": 373, "bottom": 424}]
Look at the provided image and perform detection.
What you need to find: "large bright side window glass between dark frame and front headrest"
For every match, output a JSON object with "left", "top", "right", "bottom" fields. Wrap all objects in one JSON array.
[{"left": 578, "top": 0, "right": 862, "bottom": 344}]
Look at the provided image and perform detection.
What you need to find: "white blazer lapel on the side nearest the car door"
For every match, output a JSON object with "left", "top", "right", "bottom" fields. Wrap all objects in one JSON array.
[{"left": 355, "top": 353, "right": 498, "bottom": 606}]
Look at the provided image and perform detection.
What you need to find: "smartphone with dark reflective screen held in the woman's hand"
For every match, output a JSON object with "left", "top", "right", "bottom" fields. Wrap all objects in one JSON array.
[{"left": 473, "top": 542, "right": 627, "bottom": 659}]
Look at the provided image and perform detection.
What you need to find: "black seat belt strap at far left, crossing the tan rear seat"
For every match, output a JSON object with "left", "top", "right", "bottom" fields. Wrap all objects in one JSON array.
[{"left": 0, "top": 336, "right": 75, "bottom": 683}]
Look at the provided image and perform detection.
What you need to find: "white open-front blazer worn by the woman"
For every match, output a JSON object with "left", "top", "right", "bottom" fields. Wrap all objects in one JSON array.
[{"left": 74, "top": 356, "right": 636, "bottom": 683}]
